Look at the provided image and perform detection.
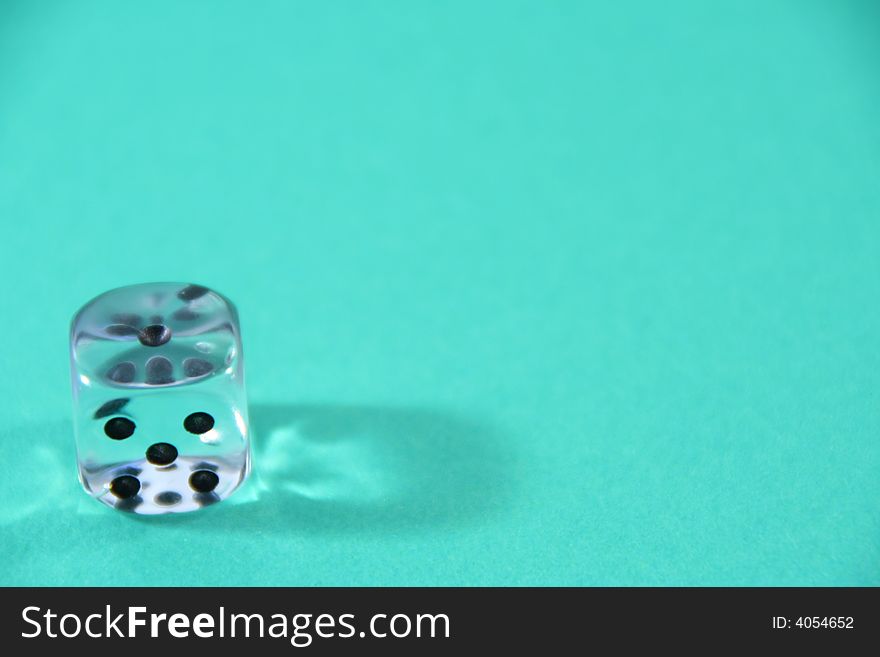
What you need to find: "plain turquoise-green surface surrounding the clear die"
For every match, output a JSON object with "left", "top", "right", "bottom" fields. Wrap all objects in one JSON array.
[{"left": 0, "top": 0, "right": 880, "bottom": 585}]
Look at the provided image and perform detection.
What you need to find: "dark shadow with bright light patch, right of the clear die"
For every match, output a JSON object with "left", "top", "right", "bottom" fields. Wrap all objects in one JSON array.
[{"left": 204, "top": 404, "right": 516, "bottom": 535}]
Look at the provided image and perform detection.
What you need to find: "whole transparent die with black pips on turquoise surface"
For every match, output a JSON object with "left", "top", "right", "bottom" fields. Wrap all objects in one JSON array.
[{"left": 70, "top": 283, "right": 250, "bottom": 514}]
